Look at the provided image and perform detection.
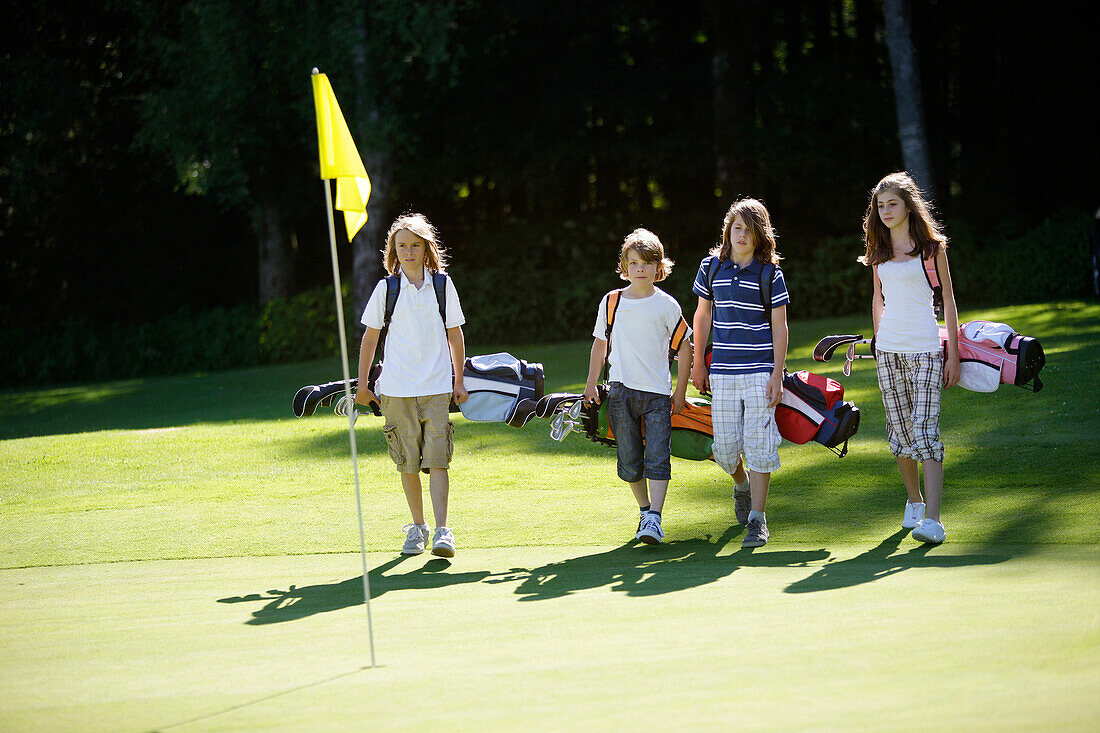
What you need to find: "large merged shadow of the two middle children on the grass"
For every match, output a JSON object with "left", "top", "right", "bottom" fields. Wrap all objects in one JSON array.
[{"left": 495, "top": 526, "right": 828, "bottom": 601}]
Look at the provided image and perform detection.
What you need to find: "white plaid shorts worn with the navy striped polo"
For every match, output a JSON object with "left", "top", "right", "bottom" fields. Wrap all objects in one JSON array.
[{"left": 711, "top": 373, "right": 782, "bottom": 473}]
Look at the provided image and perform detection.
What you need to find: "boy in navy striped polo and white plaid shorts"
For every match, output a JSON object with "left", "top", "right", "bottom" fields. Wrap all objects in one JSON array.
[{"left": 691, "top": 198, "right": 790, "bottom": 547}]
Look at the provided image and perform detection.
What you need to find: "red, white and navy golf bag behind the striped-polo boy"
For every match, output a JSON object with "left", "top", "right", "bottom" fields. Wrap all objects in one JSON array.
[{"left": 776, "top": 371, "right": 859, "bottom": 458}]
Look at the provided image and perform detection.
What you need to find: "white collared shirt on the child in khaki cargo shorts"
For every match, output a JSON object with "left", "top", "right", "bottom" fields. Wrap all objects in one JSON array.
[{"left": 362, "top": 269, "right": 466, "bottom": 397}]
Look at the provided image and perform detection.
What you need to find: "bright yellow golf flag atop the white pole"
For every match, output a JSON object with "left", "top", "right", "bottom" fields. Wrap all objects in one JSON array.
[{"left": 312, "top": 74, "right": 371, "bottom": 241}]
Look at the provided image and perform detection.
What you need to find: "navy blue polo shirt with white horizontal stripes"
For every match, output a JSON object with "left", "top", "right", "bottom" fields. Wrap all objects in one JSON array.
[{"left": 692, "top": 254, "right": 791, "bottom": 374}]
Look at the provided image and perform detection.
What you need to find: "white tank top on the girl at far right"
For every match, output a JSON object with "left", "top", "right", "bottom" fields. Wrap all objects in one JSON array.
[{"left": 875, "top": 258, "right": 941, "bottom": 353}]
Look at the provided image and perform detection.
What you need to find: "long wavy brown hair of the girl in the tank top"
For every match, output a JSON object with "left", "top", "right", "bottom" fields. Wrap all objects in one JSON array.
[{"left": 858, "top": 171, "right": 947, "bottom": 265}]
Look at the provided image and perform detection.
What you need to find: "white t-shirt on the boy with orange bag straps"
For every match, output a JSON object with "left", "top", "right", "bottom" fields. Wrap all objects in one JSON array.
[{"left": 592, "top": 287, "right": 691, "bottom": 394}]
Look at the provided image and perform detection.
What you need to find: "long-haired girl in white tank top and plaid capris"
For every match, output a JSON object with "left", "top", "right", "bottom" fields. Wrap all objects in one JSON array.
[{"left": 859, "top": 173, "right": 959, "bottom": 545}]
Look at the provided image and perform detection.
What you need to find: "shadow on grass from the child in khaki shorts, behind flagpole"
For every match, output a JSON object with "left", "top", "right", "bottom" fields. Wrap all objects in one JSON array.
[{"left": 218, "top": 556, "right": 490, "bottom": 626}]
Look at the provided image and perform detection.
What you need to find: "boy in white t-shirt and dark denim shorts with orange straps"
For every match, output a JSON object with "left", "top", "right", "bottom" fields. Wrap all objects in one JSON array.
[{"left": 584, "top": 229, "right": 692, "bottom": 545}]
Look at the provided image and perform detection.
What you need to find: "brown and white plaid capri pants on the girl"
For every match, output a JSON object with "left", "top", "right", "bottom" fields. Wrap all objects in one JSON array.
[{"left": 876, "top": 351, "right": 944, "bottom": 462}]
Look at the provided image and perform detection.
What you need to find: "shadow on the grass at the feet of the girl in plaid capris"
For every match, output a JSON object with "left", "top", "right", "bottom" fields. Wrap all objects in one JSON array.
[{"left": 784, "top": 529, "right": 1012, "bottom": 593}]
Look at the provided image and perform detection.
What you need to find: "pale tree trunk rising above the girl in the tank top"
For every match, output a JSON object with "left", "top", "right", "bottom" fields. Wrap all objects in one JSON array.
[{"left": 883, "top": 0, "right": 935, "bottom": 198}]
